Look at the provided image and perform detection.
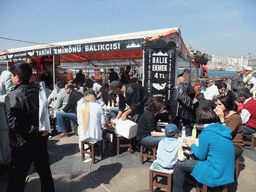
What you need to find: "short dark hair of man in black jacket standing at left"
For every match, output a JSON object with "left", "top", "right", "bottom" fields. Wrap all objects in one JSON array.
[{"left": 10, "top": 61, "right": 32, "bottom": 83}]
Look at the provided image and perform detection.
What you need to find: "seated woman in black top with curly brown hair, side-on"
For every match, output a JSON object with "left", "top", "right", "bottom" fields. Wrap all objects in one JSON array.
[{"left": 136, "top": 97, "right": 166, "bottom": 147}]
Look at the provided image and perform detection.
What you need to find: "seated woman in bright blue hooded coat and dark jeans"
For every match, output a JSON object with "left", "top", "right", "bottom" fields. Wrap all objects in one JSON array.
[{"left": 173, "top": 106, "right": 235, "bottom": 192}]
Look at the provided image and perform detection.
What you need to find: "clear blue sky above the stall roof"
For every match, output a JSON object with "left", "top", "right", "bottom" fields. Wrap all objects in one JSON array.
[{"left": 0, "top": 0, "right": 256, "bottom": 57}]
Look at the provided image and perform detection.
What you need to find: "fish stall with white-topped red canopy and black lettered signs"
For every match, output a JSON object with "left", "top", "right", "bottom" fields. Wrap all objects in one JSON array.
[{"left": 0, "top": 28, "right": 200, "bottom": 97}]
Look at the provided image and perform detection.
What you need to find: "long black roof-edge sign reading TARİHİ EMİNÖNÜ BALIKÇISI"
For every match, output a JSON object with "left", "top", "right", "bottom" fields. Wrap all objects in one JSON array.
[{"left": 0, "top": 39, "right": 144, "bottom": 61}]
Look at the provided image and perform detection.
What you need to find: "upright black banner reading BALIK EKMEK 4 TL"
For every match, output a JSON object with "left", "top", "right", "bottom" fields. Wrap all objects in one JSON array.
[{"left": 143, "top": 40, "right": 176, "bottom": 100}]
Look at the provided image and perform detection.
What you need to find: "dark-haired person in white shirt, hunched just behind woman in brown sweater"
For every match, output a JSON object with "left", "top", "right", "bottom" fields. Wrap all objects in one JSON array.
[{"left": 204, "top": 82, "right": 227, "bottom": 100}]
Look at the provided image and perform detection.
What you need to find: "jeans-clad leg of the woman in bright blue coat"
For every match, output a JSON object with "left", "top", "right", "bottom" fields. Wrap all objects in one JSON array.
[{"left": 172, "top": 160, "right": 199, "bottom": 192}]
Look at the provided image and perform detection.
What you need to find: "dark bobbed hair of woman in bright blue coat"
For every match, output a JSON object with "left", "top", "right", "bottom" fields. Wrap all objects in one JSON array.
[{"left": 196, "top": 106, "right": 219, "bottom": 124}]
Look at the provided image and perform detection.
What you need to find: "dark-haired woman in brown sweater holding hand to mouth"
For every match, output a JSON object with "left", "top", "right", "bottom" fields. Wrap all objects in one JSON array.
[{"left": 214, "top": 96, "right": 244, "bottom": 158}]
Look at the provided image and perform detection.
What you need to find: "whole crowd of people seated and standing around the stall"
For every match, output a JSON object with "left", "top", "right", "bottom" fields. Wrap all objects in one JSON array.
[{"left": 0, "top": 62, "right": 256, "bottom": 191}]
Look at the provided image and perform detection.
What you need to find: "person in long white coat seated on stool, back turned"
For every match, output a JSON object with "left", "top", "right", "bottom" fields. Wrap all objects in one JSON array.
[{"left": 77, "top": 90, "right": 105, "bottom": 152}]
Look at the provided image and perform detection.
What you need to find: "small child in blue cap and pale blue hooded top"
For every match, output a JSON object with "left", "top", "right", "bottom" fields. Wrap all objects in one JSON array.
[{"left": 157, "top": 124, "right": 186, "bottom": 169}]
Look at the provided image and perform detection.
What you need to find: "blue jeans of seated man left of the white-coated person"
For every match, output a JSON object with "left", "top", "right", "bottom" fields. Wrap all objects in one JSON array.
[{"left": 57, "top": 111, "right": 77, "bottom": 133}]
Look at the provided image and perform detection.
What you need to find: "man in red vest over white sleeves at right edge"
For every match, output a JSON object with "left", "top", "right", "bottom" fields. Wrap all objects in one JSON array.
[{"left": 238, "top": 88, "right": 256, "bottom": 134}]
